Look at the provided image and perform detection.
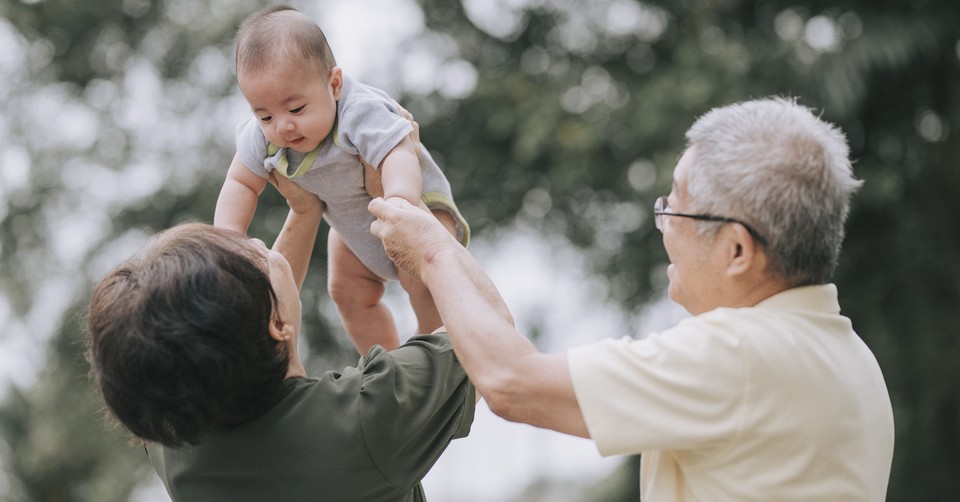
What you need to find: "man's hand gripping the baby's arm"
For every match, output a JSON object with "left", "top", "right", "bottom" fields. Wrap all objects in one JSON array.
[{"left": 367, "top": 197, "right": 460, "bottom": 277}]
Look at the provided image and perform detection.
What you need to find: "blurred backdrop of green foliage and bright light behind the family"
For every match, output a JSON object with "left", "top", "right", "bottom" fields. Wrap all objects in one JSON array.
[{"left": 0, "top": 0, "right": 960, "bottom": 502}]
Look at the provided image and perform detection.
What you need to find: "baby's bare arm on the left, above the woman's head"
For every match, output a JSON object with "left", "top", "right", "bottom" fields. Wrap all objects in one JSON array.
[{"left": 213, "top": 156, "right": 267, "bottom": 234}]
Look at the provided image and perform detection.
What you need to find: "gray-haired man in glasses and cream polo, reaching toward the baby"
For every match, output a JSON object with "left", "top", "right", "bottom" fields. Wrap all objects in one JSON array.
[{"left": 370, "top": 98, "right": 894, "bottom": 501}]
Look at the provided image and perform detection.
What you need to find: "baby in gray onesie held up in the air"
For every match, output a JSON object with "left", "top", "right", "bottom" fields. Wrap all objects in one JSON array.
[{"left": 214, "top": 6, "right": 470, "bottom": 354}]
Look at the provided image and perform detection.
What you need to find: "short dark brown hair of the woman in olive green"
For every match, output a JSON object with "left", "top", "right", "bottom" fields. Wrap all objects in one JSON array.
[{"left": 87, "top": 223, "right": 289, "bottom": 446}]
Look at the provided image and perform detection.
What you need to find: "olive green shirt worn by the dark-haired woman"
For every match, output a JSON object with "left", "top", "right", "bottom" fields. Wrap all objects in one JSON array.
[{"left": 147, "top": 334, "right": 476, "bottom": 502}]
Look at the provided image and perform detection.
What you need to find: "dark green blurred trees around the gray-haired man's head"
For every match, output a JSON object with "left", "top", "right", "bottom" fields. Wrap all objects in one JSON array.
[{"left": 414, "top": 0, "right": 960, "bottom": 500}]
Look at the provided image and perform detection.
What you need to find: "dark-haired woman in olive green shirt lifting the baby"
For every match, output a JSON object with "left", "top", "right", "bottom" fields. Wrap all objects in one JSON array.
[{"left": 87, "top": 175, "right": 476, "bottom": 501}]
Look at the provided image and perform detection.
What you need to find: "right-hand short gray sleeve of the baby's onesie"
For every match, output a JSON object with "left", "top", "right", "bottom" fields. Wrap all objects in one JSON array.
[{"left": 338, "top": 96, "right": 413, "bottom": 169}]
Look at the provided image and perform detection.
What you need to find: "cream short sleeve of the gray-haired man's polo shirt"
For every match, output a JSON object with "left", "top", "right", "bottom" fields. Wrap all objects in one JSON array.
[{"left": 568, "top": 322, "right": 749, "bottom": 456}]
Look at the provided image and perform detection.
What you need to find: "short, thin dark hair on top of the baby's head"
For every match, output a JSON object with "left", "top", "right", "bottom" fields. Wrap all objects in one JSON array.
[{"left": 237, "top": 5, "right": 337, "bottom": 76}]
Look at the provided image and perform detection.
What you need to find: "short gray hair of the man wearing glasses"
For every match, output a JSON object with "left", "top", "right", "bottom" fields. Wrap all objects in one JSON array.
[{"left": 686, "top": 98, "right": 862, "bottom": 286}]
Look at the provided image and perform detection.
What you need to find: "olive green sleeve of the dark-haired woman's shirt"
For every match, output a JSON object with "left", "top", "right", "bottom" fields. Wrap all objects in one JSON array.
[{"left": 360, "top": 334, "right": 476, "bottom": 490}]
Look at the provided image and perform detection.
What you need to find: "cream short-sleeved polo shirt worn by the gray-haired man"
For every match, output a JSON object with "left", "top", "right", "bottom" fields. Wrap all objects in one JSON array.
[{"left": 568, "top": 284, "right": 894, "bottom": 502}]
